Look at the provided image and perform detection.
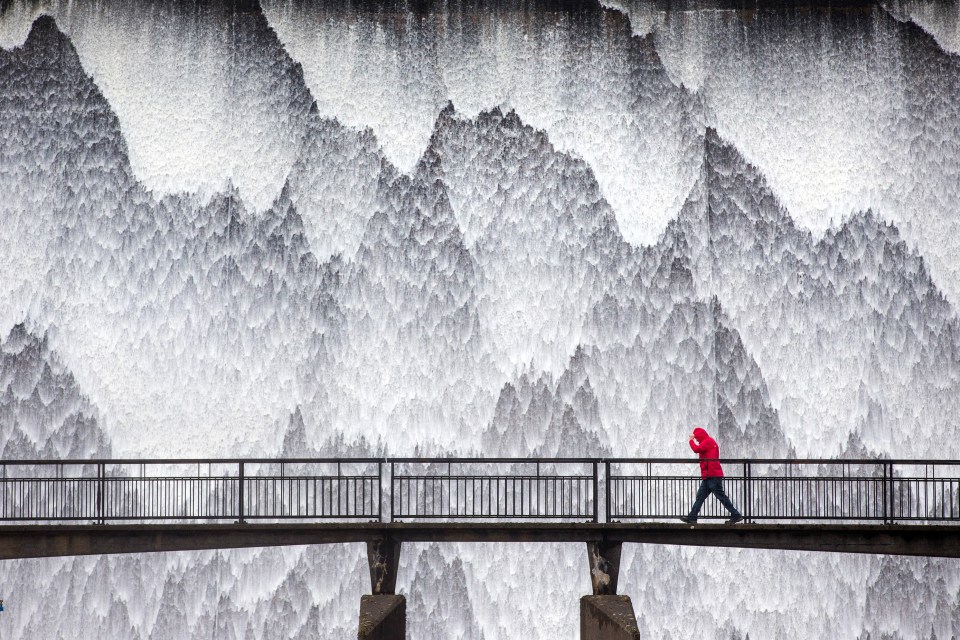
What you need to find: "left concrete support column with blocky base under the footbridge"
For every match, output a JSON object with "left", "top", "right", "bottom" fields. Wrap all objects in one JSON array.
[{"left": 357, "top": 538, "right": 407, "bottom": 640}]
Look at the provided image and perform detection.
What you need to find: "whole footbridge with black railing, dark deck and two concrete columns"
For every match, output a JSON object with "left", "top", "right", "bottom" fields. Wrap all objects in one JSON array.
[{"left": 0, "top": 458, "right": 960, "bottom": 639}]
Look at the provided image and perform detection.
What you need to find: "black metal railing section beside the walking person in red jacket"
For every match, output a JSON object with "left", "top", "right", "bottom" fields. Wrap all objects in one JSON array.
[{"left": 604, "top": 458, "right": 960, "bottom": 523}]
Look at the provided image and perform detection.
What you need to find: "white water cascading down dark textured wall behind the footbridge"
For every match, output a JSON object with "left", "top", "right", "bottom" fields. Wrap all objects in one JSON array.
[{"left": 0, "top": 0, "right": 960, "bottom": 640}]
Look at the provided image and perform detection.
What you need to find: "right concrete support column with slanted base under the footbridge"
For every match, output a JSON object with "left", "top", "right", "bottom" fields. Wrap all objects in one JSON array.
[{"left": 580, "top": 540, "right": 640, "bottom": 640}]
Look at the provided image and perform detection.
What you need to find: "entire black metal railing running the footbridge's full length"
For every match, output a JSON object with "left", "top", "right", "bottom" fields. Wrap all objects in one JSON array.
[{"left": 0, "top": 458, "right": 960, "bottom": 524}]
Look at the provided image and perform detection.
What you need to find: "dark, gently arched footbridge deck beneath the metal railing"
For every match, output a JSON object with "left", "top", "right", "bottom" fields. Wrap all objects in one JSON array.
[{"left": 0, "top": 522, "right": 960, "bottom": 559}]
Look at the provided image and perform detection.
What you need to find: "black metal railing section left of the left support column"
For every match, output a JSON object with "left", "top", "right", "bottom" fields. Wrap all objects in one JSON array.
[{"left": 0, "top": 458, "right": 382, "bottom": 524}]
